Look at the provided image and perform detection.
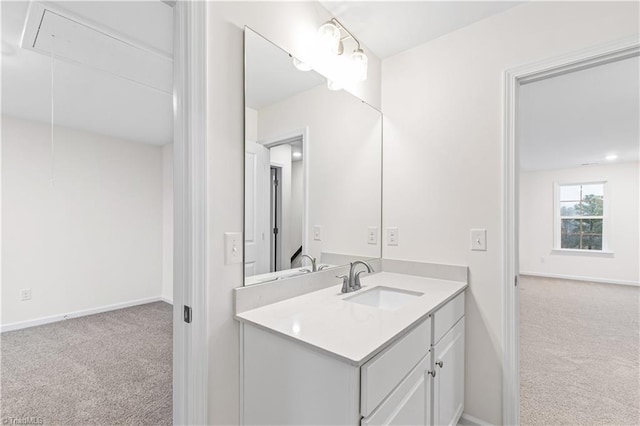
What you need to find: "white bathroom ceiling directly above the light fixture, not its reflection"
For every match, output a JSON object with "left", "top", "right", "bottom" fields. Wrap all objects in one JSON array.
[{"left": 320, "top": 0, "right": 523, "bottom": 59}]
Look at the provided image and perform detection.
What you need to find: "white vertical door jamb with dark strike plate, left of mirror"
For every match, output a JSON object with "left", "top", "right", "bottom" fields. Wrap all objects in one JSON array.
[{"left": 173, "top": 1, "right": 209, "bottom": 425}]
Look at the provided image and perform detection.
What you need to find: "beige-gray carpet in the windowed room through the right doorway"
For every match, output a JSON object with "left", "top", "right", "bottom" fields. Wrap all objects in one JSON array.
[{"left": 520, "top": 276, "right": 640, "bottom": 425}]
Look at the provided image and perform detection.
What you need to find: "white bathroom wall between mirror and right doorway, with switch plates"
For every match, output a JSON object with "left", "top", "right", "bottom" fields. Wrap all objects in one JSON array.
[{"left": 382, "top": 2, "right": 638, "bottom": 424}]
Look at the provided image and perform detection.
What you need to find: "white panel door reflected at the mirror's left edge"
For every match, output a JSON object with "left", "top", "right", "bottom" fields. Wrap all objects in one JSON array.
[{"left": 244, "top": 141, "right": 270, "bottom": 277}]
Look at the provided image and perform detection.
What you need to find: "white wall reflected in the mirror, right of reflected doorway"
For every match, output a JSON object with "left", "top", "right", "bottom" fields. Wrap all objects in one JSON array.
[{"left": 258, "top": 85, "right": 382, "bottom": 259}]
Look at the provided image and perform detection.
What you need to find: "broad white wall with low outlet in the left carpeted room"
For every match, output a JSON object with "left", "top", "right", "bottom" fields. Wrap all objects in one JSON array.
[{"left": 2, "top": 116, "right": 162, "bottom": 325}]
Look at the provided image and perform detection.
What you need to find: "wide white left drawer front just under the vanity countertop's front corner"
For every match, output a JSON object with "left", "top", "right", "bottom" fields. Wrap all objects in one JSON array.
[{"left": 360, "top": 318, "right": 431, "bottom": 417}]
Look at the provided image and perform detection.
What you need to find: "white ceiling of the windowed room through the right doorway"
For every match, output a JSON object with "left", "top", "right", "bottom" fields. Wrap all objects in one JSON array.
[{"left": 518, "top": 57, "right": 640, "bottom": 171}]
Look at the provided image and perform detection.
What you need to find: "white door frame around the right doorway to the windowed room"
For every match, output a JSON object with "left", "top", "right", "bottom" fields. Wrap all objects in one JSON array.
[{"left": 502, "top": 36, "right": 640, "bottom": 425}]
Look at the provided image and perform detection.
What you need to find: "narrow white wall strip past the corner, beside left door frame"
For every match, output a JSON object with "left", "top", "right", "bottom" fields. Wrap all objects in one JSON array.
[{"left": 162, "top": 144, "right": 173, "bottom": 303}]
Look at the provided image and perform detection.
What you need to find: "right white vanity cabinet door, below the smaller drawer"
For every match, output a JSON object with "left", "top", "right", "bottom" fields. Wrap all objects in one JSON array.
[{"left": 433, "top": 317, "right": 464, "bottom": 426}]
